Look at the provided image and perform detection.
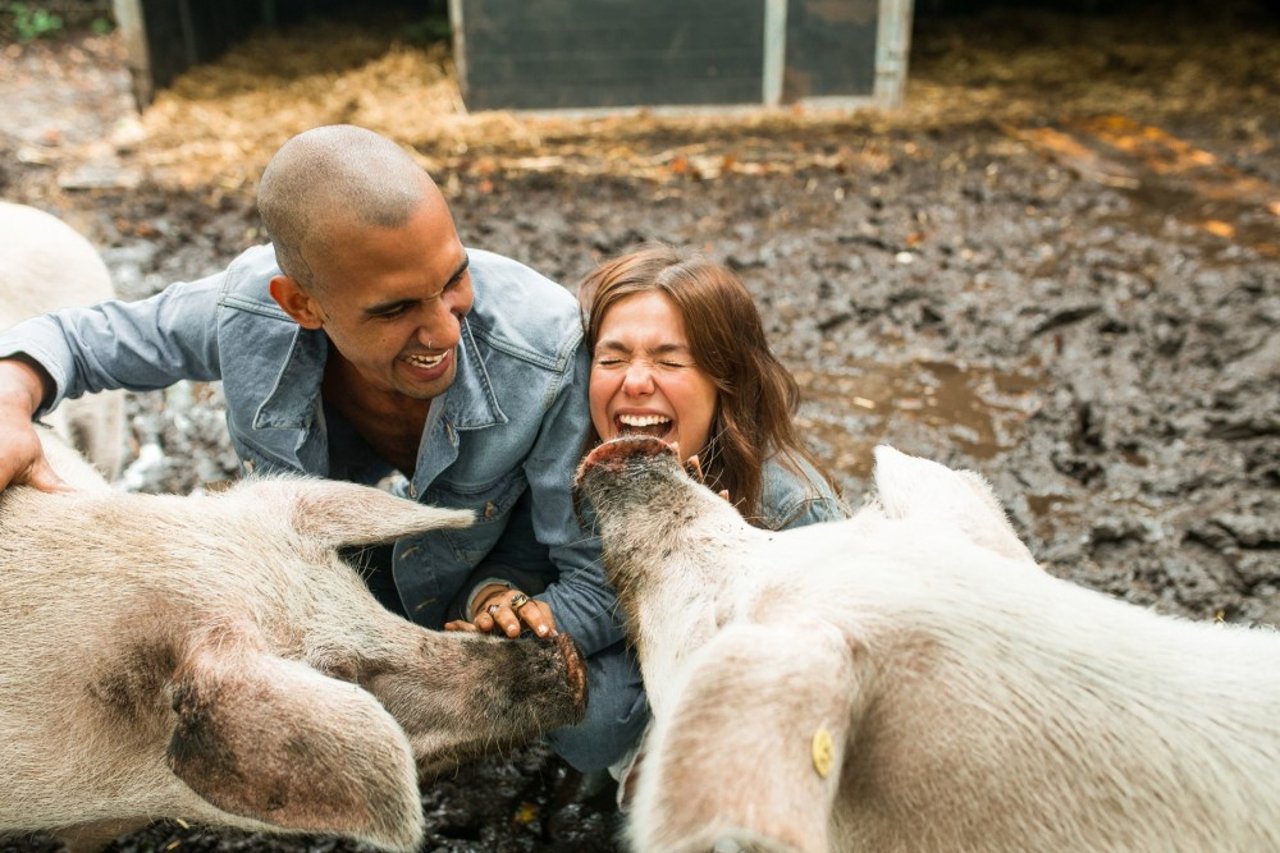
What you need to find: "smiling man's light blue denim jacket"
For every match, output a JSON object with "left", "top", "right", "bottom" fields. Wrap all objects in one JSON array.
[{"left": 0, "top": 246, "right": 622, "bottom": 654}]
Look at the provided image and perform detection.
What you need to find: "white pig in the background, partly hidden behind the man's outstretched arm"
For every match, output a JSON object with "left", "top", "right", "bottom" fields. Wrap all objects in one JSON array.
[{"left": 0, "top": 201, "right": 124, "bottom": 478}]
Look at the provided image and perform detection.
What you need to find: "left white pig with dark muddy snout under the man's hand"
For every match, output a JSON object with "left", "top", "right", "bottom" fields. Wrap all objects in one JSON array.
[{"left": 0, "top": 427, "right": 585, "bottom": 850}]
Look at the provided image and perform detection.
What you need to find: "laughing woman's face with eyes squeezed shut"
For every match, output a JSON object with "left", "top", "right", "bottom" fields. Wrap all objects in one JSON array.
[{"left": 590, "top": 291, "right": 717, "bottom": 459}]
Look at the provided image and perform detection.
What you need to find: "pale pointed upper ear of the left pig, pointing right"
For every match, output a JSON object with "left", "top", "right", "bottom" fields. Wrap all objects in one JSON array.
[{"left": 246, "top": 478, "right": 475, "bottom": 548}]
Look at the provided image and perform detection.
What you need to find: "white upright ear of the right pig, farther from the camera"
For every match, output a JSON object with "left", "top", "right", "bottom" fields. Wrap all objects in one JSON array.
[{"left": 876, "top": 444, "right": 1036, "bottom": 562}]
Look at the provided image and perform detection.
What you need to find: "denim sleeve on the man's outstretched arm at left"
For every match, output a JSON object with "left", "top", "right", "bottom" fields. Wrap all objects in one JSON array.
[{"left": 0, "top": 273, "right": 224, "bottom": 414}]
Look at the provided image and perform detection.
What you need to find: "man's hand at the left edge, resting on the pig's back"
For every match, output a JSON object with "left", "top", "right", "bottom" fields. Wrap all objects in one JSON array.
[{"left": 0, "top": 359, "right": 72, "bottom": 492}]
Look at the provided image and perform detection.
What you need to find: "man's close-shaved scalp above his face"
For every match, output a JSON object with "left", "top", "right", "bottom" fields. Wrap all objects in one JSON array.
[{"left": 257, "top": 124, "right": 439, "bottom": 289}]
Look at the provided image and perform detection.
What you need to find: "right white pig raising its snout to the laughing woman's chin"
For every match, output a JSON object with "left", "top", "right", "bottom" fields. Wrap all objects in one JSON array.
[{"left": 579, "top": 438, "right": 1280, "bottom": 853}]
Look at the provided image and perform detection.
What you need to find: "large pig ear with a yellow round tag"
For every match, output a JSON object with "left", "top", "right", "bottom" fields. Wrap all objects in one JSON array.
[{"left": 628, "top": 622, "right": 864, "bottom": 853}]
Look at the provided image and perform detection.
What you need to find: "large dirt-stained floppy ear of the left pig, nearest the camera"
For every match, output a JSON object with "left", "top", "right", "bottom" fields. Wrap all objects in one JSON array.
[{"left": 166, "top": 647, "right": 422, "bottom": 850}]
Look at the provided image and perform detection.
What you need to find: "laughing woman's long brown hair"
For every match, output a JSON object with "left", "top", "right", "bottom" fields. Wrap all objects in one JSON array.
[{"left": 579, "top": 243, "right": 835, "bottom": 517}]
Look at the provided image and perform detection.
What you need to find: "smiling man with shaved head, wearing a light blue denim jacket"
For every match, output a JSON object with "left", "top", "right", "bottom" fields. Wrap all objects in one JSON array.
[{"left": 0, "top": 126, "right": 645, "bottom": 771}]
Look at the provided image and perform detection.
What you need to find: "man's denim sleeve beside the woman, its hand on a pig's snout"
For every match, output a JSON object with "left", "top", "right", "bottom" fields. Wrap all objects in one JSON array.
[{"left": 525, "top": 346, "right": 623, "bottom": 656}]
